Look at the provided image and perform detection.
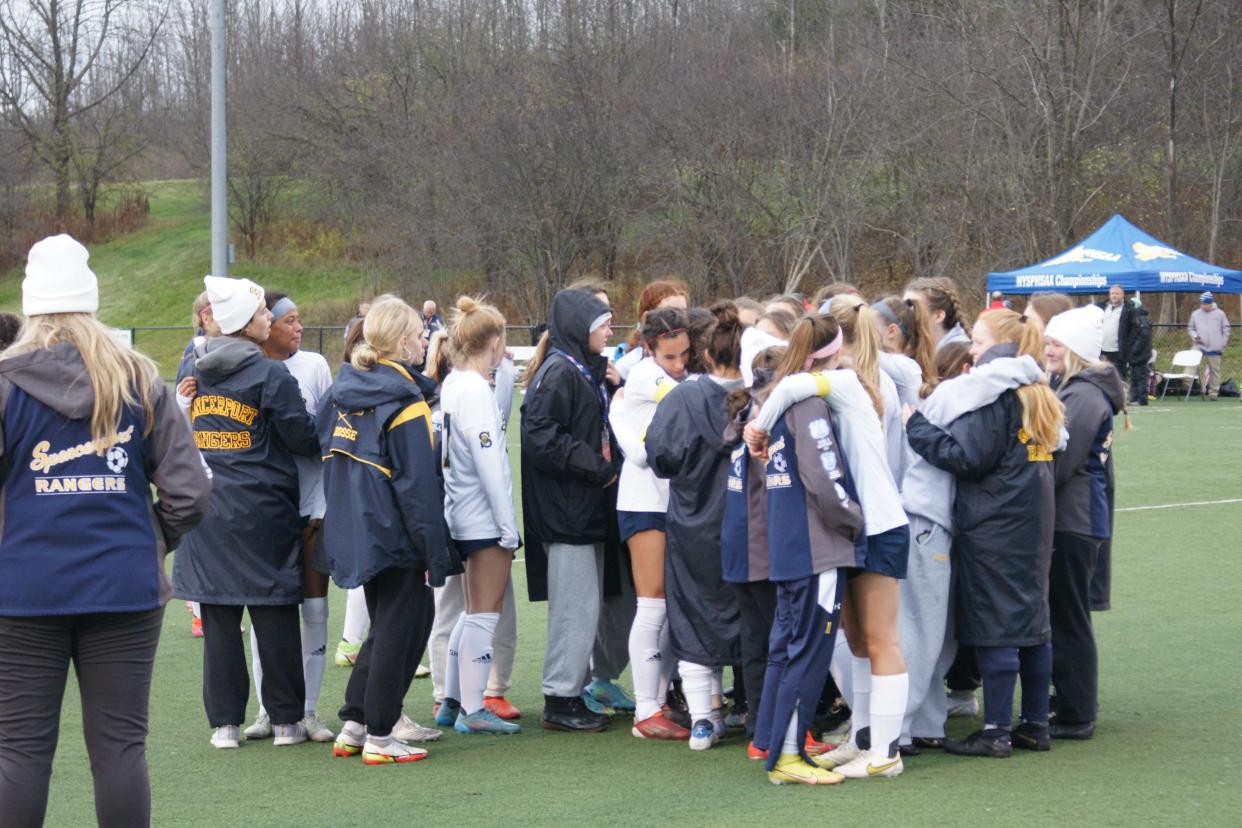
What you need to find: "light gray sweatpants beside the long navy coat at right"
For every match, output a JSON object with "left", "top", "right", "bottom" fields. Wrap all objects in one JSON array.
[{"left": 897, "top": 515, "right": 958, "bottom": 745}]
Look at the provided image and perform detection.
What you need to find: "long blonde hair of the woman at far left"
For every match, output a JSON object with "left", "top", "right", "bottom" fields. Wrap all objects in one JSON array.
[{"left": 0, "top": 313, "right": 159, "bottom": 454}]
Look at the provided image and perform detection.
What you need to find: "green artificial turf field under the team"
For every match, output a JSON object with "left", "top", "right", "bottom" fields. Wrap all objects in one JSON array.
[{"left": 31, "top": 400, "right": 1242, "bottom": 827}]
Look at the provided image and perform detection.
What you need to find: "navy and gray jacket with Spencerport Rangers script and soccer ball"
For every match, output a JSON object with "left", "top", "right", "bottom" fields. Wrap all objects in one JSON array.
[{"left": 0, "top": 344, "right": 211, "bottom": 616}]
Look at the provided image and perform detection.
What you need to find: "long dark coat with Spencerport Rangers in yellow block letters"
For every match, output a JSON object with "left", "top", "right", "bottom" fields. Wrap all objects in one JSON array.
[{"left": 173, "top": 336, "right": 319, "bottom": 606}]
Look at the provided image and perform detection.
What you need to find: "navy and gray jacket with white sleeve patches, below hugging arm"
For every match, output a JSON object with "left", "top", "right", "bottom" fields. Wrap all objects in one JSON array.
[{"left": 764, "top": 397, "right": 866, "bottom": 581}]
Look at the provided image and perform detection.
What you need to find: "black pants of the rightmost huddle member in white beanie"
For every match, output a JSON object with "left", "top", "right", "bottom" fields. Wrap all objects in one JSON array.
[{"left": 1048, "top": 531, "right": 1102, "bottom": 724}]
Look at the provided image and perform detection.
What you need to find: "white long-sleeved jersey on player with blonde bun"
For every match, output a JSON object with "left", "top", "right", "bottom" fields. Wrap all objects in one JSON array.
[{"left": 440, "top": 370, "right": 519, "bottom": 549}]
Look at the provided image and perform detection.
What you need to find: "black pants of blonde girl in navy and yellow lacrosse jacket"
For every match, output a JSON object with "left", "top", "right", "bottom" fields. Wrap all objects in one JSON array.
[{"left": 340, "top": 567, "right": 436, "bottom": 736}]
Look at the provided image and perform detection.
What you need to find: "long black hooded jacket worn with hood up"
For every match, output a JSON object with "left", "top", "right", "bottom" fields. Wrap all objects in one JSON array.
[{"left": 522, "top": 289, "right": 621, "bottom": 601}]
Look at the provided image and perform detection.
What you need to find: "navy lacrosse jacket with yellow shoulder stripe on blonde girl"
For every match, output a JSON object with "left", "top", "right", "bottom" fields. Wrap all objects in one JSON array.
[{"left": 318, "top": 360, "right": 450, "bottom": 588}]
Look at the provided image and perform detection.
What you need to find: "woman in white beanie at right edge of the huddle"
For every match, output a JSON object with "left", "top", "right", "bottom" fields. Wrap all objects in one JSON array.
[{"left": 1045, "top": 301, "right": 1125, "bottom": 739}]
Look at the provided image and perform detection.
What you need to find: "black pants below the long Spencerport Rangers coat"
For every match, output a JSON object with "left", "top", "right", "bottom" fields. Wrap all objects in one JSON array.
[{"left": 199, "top": 603, "right": 307, "bottom": 727}]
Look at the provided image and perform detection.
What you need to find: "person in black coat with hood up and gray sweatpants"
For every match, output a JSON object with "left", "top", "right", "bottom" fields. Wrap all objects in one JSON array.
[{"left": 522, "top": 289, "right": 621, "bottom": 731}]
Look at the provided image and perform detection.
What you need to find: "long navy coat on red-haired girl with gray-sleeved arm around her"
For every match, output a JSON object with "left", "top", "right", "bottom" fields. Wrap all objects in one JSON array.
[{"left": 905, "top": 354, "right": 1056, "bottom": 647}]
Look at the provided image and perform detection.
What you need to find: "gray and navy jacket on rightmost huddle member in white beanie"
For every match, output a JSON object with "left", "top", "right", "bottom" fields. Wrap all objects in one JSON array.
[{"left": 1056, "top": 365, "right": 1125, "bottom": 538}]
